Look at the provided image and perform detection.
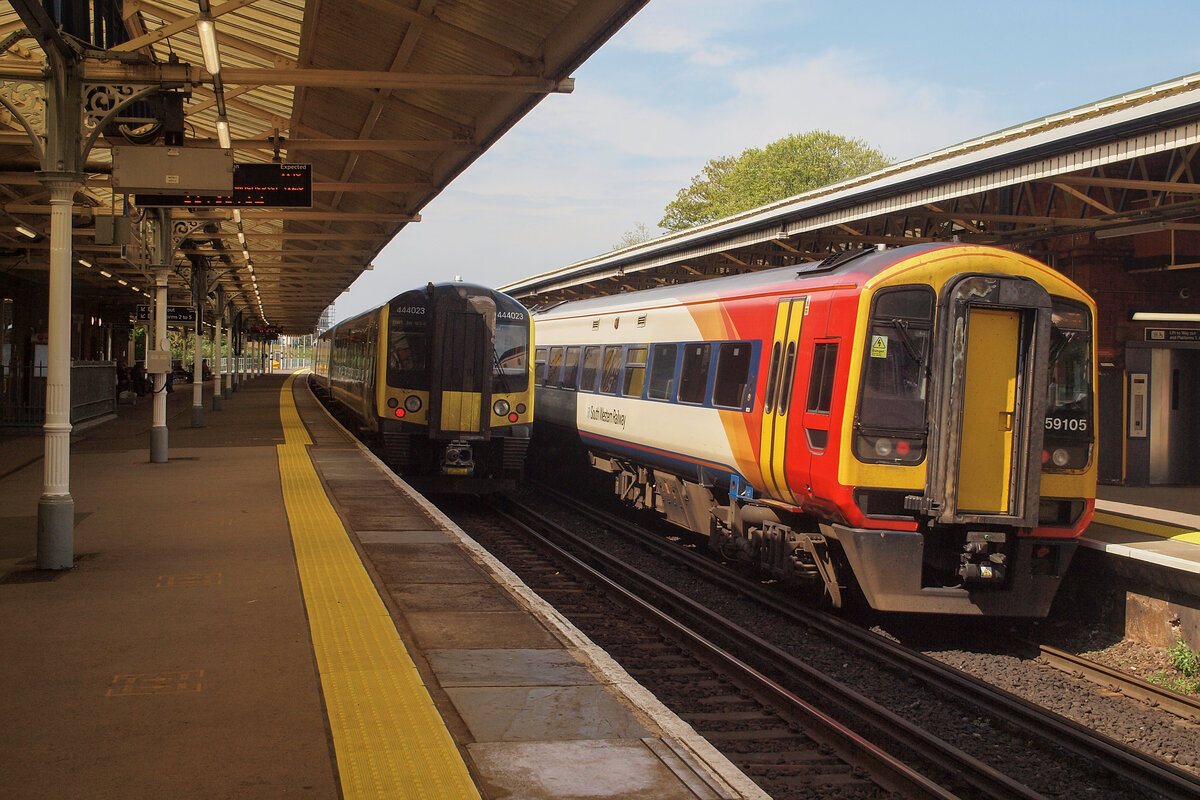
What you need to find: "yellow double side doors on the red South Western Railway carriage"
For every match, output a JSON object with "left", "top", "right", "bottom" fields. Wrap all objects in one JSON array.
[{"left": 758, "top": 297, "right": 808, "bottom": 503}]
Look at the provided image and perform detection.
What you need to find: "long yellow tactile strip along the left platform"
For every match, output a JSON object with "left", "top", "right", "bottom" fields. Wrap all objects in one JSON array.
[{"left": 278, "top": 374, "right": 480, "bottom": 800}]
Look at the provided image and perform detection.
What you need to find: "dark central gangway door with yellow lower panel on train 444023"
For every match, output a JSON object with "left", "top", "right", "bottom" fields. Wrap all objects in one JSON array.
[{"left": 430, "top": 293, "right": 496, "bottom": 438}]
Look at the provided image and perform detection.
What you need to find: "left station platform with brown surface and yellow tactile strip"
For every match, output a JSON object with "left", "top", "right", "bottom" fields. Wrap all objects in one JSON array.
[{"left": 0, "top": 374, "right": 766, "bottom": 800}]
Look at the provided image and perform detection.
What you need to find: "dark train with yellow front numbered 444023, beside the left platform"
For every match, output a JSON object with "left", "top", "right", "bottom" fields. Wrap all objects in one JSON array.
[{"left": 311, "top": 282, "right": 534, "bottom": 494}]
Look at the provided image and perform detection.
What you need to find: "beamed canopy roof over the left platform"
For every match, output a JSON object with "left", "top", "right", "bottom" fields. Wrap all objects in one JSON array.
[{"left": 0, "top": 0, "right": 646, "bottom": 333}]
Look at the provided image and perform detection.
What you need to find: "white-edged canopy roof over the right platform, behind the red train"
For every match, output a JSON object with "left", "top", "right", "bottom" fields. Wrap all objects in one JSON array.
[{"left": 500, "top": 74, "right": 1200, "bottom": 311}]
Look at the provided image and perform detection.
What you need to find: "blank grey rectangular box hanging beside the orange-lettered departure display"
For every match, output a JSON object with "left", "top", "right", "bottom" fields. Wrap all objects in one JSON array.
[{"left": 113, "top": 145, "right": 233, "bottom": 194}]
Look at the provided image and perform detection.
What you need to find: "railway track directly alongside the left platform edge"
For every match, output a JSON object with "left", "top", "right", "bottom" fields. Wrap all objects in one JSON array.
[{"left": 445, "top": 496, "right": 969, "bottom": 800}]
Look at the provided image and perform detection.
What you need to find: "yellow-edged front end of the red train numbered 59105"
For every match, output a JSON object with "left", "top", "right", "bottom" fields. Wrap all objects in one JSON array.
[{"left": 822, "top": 257, "right": 1096, "bottom": 616}]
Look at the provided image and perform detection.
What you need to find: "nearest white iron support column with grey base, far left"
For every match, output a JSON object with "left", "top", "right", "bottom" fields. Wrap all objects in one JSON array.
[{"left": 37, "top": 172, "right": 84, "bottom": 570}]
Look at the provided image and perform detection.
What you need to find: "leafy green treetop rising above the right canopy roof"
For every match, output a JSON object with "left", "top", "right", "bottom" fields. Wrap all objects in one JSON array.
[{"left": 659, "top": 131, "right": 892, "bottom": 230}]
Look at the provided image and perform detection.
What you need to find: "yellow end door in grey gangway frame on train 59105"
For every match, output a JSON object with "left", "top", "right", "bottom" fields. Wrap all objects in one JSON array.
[{"left": 929, "top": 276, "right": 1051, "bottom": 527}]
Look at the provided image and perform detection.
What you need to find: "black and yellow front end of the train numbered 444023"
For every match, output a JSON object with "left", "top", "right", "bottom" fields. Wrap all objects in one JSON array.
[{"left": 379, "top": 284, "right": 533, "bottom": 493}]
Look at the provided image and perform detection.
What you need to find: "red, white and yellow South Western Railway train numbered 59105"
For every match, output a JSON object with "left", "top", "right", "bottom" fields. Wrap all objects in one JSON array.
[{"left": 533, "top": 242, "right": 1097, "bottom": 618}]
